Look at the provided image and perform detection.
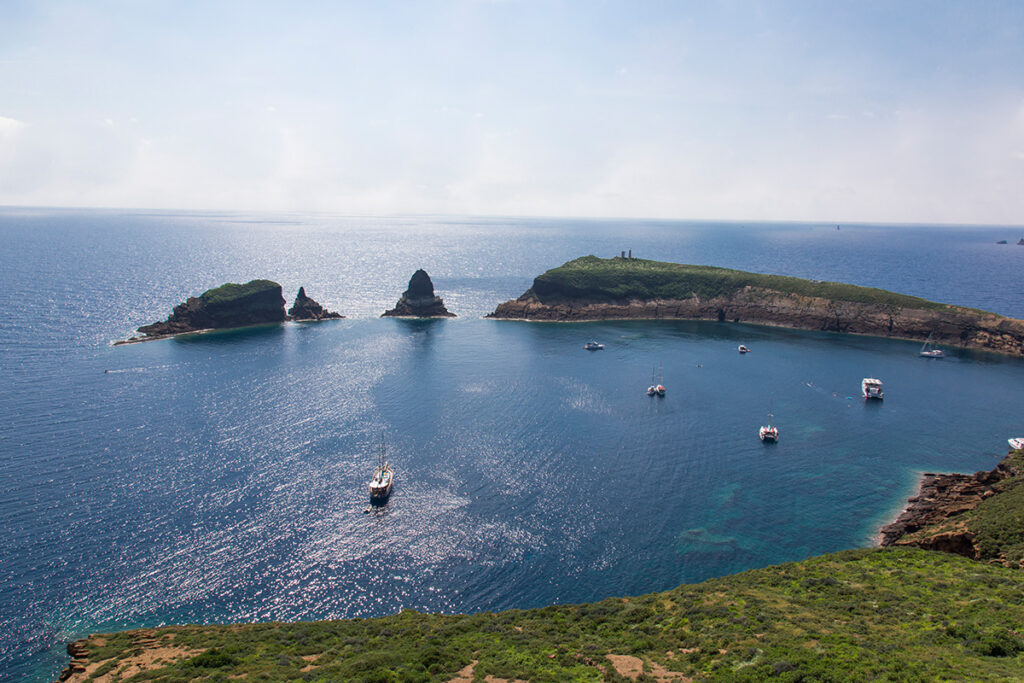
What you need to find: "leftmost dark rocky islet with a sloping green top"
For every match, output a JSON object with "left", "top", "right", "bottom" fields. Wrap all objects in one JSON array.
[{"left": 132, "top": 280, "right": 286, "bottom": 341}]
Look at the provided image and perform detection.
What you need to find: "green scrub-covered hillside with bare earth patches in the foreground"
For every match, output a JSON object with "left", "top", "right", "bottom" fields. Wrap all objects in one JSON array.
[{"left": 61, "top": 548, "right": 1024, "bottom": 681}]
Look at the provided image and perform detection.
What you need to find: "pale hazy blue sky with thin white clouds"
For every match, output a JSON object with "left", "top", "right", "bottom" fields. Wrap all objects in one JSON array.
[{"left": 0, "top": 0, "right": 1024, "bottom": 225}]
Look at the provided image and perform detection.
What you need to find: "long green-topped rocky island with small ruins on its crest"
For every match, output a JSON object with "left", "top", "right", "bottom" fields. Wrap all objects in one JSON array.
[{"left": 487, "top": 256, "right": 1024, "bottom": 356}]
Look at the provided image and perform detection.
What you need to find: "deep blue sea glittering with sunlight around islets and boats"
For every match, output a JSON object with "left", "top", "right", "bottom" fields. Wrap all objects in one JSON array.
[{"left": 0, "top": 208, "right": 1024, "bottom": 681}]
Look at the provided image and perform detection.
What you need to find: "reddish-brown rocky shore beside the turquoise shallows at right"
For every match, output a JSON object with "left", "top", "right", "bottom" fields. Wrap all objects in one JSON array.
[{"left": 879, "top": 452, "right": 1022, "bottom": 559}]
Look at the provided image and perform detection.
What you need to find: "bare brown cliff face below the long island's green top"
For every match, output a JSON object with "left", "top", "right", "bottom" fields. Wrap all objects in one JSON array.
[{"left": 487, "top": 287, "right": 1024, "bottom": 355}]
